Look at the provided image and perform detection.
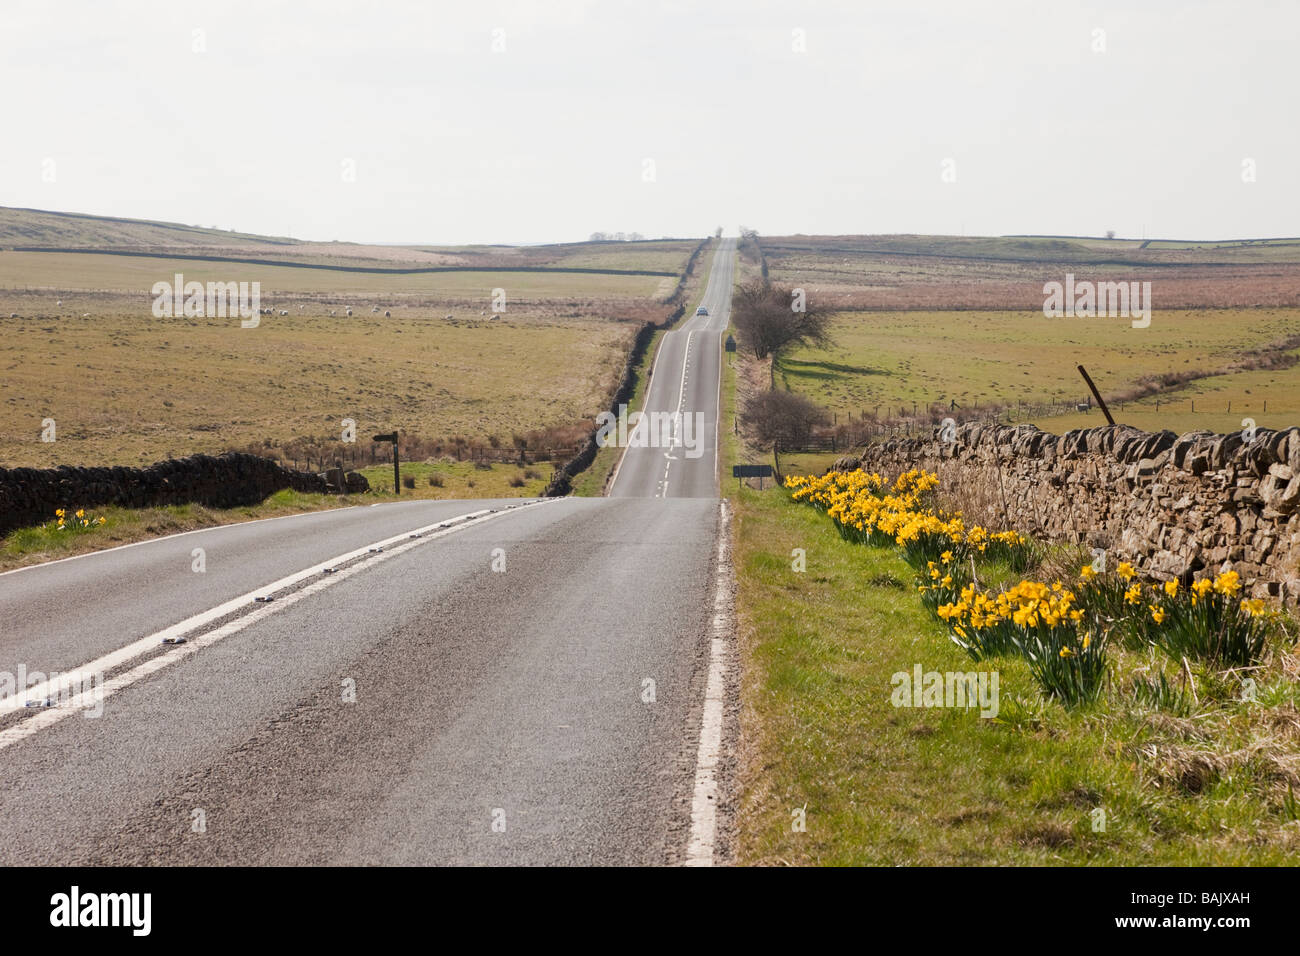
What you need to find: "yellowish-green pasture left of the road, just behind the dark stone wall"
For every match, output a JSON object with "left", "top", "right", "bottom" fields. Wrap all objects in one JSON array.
[{"left": 0, "top": 294, "right": 633, "bottom": 467}]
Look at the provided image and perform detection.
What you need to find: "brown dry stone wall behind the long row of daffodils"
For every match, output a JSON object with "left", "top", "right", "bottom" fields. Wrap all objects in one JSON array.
[{"left": 837, "top": 423, "right": 1300, "bottom": 604}]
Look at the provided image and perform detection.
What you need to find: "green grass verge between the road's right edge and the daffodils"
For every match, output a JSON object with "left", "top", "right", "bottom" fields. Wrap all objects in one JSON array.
[{"left": 733, "top": 489, "right": 1300, "bottom": 865}]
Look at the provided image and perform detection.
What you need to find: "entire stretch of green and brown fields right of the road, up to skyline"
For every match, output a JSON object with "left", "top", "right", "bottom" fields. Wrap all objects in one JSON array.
[{"left": 757, "top": 235, "right": 1300, "bottom": 442}]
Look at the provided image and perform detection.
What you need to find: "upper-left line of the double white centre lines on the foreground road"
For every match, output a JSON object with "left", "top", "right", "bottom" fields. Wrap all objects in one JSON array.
[{"left": 0, "top": 498, "right": 546, "bottom": 715}]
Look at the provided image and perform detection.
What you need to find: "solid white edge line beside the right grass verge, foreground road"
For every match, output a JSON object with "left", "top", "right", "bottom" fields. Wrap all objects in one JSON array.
[{"left": 685, "top": 498, "right": 731, "bottom": 866}]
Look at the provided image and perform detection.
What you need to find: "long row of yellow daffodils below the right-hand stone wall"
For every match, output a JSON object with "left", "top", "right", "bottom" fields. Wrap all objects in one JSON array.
[{"left": 785, "top": 470, "right": 1278, "bottom": 706}]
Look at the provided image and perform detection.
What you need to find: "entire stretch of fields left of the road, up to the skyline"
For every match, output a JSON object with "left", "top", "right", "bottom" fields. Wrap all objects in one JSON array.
[{"left": 0, "top": 208, "right": 702, "bottom": 476}]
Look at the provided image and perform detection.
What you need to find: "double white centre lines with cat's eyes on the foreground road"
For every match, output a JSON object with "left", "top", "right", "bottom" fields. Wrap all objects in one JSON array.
[{"left": 0, "top": 499, "right": 538, "bottom": 750}]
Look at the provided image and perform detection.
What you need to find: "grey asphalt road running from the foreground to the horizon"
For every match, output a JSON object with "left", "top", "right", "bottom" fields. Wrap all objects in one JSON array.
[{"left": 0, "top": 241, "right": 733, "bottom": 865}]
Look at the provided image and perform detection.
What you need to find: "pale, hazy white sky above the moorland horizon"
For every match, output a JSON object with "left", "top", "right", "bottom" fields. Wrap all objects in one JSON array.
[{"left": 0, "top": 0, "right": 1300, "bottom": 245}]
